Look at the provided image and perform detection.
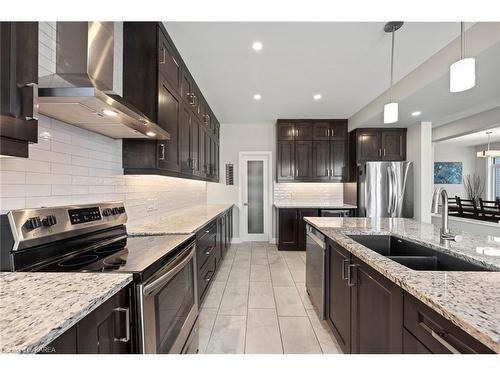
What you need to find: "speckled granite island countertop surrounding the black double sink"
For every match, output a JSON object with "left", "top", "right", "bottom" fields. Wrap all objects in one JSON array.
[{"left": 304, "top": 217, "right": 500, "bottom": 353}]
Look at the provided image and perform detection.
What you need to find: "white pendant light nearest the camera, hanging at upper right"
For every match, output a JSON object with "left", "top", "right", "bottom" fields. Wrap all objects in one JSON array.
[{"left": 450, "top": 22, "right": 476, "bottom": 92}]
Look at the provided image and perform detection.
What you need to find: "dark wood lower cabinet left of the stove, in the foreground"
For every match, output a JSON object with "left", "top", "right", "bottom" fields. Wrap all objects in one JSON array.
[{"left": 40, "top": 287, "right": 134, "bottom": 354}]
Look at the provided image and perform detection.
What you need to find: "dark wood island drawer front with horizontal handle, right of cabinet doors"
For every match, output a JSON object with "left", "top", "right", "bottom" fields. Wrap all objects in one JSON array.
[{"left": 404, "top": 293, "right": 493, "bottom": 354}]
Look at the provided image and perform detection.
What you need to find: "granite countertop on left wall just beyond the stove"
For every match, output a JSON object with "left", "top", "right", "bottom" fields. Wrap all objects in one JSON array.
[{"left": 127, "top": 204, "right": 233, "bottom": 236}]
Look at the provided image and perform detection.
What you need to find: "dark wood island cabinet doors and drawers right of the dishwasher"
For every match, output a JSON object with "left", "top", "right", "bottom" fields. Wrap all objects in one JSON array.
[{"left": 326, "top": 239, "right": 493, "bottom": 354}]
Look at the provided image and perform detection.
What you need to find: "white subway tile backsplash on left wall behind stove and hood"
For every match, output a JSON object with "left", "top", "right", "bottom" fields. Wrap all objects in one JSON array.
[{"left": 0, "top": 22, "right": 207, "bottom": 221}]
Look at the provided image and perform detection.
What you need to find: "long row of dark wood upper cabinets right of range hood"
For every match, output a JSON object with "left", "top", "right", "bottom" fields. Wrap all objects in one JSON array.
[{"left": 123, "top": 22, "right": 220, "bottom": 182}]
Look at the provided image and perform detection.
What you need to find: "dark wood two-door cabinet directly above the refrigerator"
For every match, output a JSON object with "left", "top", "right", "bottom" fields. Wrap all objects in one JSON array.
[{"left": 352, "top": 128, "right": 406, "bottom": 163}]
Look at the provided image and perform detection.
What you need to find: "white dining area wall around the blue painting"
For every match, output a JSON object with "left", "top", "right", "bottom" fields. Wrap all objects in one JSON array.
[{"left": 433, "top": 142, "right": 477, "bottom": 199}]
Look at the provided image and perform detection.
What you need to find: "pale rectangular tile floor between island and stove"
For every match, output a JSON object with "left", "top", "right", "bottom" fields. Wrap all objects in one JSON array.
[{"left": 199, "top": 242, "right": 340, "bottom": 354}]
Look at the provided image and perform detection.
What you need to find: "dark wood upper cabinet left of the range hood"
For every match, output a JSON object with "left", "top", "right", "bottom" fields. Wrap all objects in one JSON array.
[{"left": 0, "top": 22, "right": 38, "bottom": 158}]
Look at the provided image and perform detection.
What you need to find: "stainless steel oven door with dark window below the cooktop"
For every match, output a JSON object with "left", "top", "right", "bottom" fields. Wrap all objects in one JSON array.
[{"left": 138, "top": 243, "right": 198, "bottom": 354}]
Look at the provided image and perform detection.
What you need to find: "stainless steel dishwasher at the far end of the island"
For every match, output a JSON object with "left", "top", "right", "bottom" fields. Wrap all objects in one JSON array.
[{"left": 306, "top": 224, "right": 326, "bottom": 319}]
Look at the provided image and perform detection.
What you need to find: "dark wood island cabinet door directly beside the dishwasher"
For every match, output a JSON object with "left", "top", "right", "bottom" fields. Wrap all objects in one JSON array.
[{"left": 326, "top": 240, "right": 351, "bottom": 353}]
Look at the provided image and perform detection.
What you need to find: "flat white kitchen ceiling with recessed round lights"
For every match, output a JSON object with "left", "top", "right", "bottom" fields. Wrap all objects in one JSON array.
[{"left": 165, "top": 22, "right": 472, "bottom": 123}]
